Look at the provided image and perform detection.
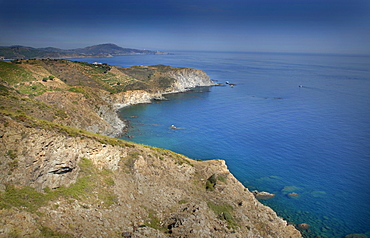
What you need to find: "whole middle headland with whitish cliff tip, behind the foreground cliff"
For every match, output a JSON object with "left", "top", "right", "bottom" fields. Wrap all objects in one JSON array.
[{"left": 0, "top": 60, "right": 216, "bottom": 136}]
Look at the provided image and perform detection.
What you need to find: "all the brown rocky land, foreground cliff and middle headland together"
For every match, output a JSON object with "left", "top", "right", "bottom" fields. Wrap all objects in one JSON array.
[{"left": 0, "top": 60, "right": 301, "bottom": 237}]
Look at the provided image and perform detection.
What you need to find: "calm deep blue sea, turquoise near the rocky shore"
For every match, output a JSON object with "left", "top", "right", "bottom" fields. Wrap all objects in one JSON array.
[{"left": 70, "top": 51, "right": 370, "bottom": 237}]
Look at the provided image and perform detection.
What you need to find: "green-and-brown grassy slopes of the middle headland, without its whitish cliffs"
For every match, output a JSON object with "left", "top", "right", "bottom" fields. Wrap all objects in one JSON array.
[{"left": 0, "top": 59, "right": 194, "bottom": 134}]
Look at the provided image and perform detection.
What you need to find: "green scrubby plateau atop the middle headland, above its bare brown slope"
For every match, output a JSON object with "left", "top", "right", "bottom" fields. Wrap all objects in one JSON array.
[{"left": 0, "top": 59, "right": 181, "bottom": 93}]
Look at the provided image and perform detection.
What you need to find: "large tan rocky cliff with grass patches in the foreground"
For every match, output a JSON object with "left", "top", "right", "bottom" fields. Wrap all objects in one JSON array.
[{"left": 0, "top": 114, "right": 301, "bottom": 238}]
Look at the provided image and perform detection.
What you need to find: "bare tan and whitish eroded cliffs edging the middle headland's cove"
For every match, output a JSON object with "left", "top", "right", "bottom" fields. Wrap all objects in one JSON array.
[{"left": 37, "top": 69, "right": 216, "bottom": 137}]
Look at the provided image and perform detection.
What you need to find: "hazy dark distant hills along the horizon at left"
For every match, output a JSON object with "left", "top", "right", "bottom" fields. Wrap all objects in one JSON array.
[{"left": 0, "top": 43, "right": 168, "bottom": 59}]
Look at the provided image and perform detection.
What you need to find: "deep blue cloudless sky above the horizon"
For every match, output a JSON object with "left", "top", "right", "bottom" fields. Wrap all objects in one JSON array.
[{"left": 0, "top": 0, "right": 370, "bottom": 54}]
